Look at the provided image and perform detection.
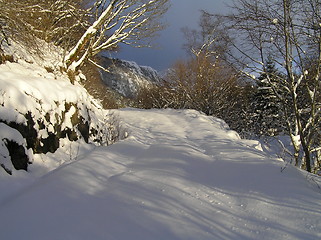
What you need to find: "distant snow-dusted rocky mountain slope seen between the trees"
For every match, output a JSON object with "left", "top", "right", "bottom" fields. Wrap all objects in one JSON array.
[{"left": 101, "top": 57, "right": 160, "bottom": 97}]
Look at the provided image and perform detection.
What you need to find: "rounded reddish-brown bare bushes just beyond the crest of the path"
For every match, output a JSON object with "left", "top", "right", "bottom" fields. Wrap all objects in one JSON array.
[{"left": 137, "top": 49, "right": 244, "bottom": 124}]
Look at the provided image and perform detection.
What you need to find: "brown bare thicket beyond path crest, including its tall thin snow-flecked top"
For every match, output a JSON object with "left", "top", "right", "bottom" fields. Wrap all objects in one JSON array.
[{"left": 137, "top": 12, "right": 248, "bottom": 133}]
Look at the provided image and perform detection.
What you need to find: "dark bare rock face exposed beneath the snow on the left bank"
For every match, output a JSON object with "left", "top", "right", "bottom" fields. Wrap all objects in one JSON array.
[{"left": 0, "top": 103, "right": 98, "bottom": 174}]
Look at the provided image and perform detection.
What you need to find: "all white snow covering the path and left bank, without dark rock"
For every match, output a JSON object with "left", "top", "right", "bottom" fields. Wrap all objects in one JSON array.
[{"left": 0, "top": 42, "right": 321, "bottom": 240}]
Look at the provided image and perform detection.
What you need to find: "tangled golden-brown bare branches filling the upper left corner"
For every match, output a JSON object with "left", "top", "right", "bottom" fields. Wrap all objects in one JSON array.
[{"left": 0, "top": 0, "right": 89, "bottom": 52}]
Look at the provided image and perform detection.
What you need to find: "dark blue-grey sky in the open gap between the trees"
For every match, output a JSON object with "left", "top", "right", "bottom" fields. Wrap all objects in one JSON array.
[{"left": 113, "top": 0, "right": 232, "bottom": 71}]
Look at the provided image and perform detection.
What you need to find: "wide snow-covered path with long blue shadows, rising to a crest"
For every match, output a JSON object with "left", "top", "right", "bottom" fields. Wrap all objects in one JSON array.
[{"left": 0, "top": 109, "right": 321, "bottom": 240}]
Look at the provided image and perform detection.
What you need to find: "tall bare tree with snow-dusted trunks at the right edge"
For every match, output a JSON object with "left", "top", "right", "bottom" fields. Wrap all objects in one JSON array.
[{"left": 208, "top": 0, "right": 321, "bottom": 172}]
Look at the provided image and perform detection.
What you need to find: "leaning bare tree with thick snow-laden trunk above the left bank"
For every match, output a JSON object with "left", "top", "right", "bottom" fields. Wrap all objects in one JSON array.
[{"left": 64, "top": 0, "right": 168, "bottom": 82}]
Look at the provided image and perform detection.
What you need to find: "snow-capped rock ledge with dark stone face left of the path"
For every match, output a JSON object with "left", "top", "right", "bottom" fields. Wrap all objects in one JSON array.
[{"left": 0, "top": 60, "right": 114, "bottom": 173}]
